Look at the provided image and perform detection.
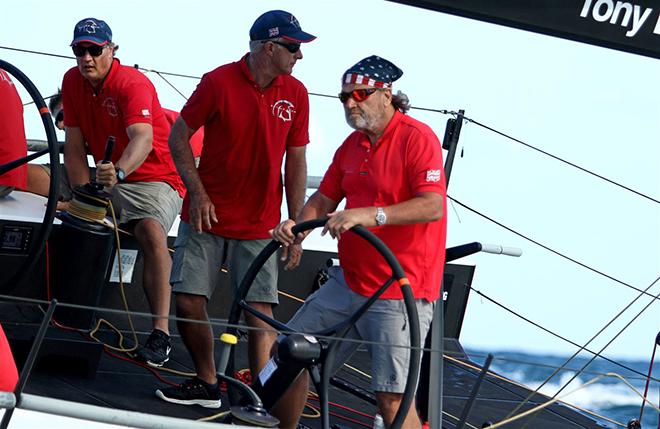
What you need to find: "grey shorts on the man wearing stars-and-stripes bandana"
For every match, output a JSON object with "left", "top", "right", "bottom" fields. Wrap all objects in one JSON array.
[{"left": 288, "top": 267, "right": 435, "bottom": 393}]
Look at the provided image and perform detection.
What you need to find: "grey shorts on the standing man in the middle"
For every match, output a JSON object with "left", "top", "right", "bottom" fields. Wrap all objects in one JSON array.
[{"left": 170, "top": 221, "right": 279, "bottom": 304}]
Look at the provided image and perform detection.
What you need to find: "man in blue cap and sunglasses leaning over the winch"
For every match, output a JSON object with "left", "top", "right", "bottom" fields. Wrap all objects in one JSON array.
[{"left": 62, "top": 18, "right": 185, "bottom": 366}]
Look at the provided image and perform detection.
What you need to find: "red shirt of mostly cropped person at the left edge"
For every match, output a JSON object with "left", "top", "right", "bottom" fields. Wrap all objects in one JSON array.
[{"left": 0, "top": 69, "right": 27, "bottom": 189}]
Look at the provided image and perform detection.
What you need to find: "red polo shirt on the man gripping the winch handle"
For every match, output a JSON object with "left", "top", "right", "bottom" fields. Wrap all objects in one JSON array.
[{"left": 62, "top": 59, "right": 185, "bottom": 196}]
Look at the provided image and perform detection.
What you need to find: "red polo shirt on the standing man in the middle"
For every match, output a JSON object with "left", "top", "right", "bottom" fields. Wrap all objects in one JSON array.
[{"left": 181, "top": 55, "right": 309, "bottom": 240}]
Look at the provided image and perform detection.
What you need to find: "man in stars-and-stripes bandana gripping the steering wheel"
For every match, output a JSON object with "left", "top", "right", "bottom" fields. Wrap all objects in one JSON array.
[{"left": 272, "top": 56, "right": 446, "bottom": 429}]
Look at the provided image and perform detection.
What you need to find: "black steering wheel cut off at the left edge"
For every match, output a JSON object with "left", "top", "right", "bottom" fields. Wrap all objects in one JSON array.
[{"left": 0, "top": 60, "right": 60, "bottom": 294}]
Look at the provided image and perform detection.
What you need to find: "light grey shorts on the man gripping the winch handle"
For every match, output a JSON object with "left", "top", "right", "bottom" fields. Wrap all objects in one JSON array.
[{"left": 111, "top": 182, "right": 183, "bottom": 234}]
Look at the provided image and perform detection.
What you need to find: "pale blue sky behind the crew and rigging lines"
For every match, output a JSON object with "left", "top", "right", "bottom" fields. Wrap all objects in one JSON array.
[{"left": 0, "top": 0, "right": 660, "bottom": 359}]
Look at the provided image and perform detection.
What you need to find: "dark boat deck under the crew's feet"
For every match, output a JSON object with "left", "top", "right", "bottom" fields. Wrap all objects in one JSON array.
[{"left": 3, "top": 312, "right": 603, "bottom": 429}]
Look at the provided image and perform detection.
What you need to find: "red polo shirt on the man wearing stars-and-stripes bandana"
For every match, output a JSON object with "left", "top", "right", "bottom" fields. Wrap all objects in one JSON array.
[{"left": 319, "top": 111, "right": 447, "bottom": 301}]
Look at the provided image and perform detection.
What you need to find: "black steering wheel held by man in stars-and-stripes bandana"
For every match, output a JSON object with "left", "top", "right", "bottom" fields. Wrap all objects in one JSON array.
[{"left": 218, "top": 218, "right": 421, "bottom": 429}]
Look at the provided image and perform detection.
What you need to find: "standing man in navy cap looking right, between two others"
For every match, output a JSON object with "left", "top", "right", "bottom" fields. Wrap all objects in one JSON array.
[{"left": 156, "top": 10, "right": 315, "bottom": 408}]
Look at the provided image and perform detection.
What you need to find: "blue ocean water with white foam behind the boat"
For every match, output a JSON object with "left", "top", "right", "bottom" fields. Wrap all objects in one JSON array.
[{"left": 467, "top": 349, "right": 660, "bottom": 429}]
